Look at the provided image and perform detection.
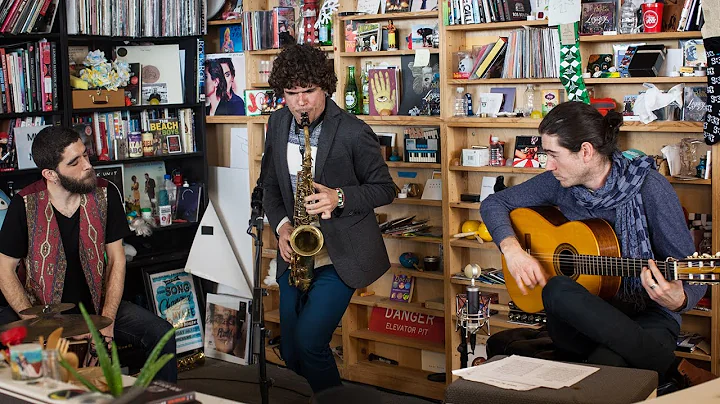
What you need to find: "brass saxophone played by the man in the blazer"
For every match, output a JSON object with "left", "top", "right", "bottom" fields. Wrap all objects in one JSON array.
[{"left": 288, "top": 112, "right": 324, "bottom": 292}]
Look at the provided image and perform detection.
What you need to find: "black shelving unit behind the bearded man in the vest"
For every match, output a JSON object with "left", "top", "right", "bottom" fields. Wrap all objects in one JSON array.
[{"left": 0, "top": 0, "right": 208, "bottom": 272}]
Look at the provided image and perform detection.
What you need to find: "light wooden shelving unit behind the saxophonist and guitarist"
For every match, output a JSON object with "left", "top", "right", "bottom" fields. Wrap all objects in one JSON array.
[{"left": 206, "top": 0, "right": 720, "bottom": 399}]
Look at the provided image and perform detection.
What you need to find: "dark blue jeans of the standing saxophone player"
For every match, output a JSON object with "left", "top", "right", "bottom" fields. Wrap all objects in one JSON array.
[{"left": 278, "top": 265, "right": 355, "bottom": 393}]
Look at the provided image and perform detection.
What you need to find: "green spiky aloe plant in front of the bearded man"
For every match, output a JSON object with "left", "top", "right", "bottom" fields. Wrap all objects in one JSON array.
[{"left": 59, "top": 303, "right": 175, "bottom": 397}]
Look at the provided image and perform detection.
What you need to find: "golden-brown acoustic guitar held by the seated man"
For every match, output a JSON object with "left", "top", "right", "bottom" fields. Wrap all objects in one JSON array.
[{"left": 502, "top": 207, "right": 720, "bottom": 313}]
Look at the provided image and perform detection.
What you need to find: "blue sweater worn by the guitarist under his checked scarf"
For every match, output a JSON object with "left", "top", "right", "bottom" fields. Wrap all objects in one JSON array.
[{"left": 480, "top": 170, "right": 707, "bottom": 324}]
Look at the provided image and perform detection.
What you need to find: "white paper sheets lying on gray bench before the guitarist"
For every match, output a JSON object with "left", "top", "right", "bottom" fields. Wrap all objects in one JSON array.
[{"left": 453, "top": 355, "right": 599, "bottom": 391}]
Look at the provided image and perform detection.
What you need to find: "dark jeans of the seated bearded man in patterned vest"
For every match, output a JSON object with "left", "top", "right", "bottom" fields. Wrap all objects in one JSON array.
[{"left": 0, "top": 300, "right": 177, "bottom": 383}]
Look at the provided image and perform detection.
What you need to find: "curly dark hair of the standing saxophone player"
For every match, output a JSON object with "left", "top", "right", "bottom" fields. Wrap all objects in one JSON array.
[{"left": 268, "top": 44, "right": 337, "bottom": 95}]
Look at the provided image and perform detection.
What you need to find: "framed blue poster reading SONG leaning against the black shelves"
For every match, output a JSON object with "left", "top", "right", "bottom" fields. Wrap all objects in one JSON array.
[{"left": 143, "top": 268, "right": 203, "bottom": 354}]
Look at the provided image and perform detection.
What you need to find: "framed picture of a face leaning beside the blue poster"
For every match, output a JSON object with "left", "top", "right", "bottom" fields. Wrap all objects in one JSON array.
[{"left": 205, "top": 293, "right": 252, "bottom": 365}]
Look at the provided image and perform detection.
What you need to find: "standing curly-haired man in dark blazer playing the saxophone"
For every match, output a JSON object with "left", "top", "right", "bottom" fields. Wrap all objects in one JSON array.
[{"left": 263, "top": 45, "right": 395, "bottom": 393}]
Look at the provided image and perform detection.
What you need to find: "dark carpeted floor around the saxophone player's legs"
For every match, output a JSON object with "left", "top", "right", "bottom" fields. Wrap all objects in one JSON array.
[{"left": 178, "top": 358, "right": 437, "bottom": 404}]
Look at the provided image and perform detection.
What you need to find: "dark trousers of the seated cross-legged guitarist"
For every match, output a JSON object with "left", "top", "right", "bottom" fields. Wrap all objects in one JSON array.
[{"left": 542, "top": 276, "right": 680, "bottom": 377}]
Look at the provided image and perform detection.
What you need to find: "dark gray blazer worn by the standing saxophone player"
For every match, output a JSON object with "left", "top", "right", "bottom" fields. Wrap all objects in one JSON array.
[{"left": 263, "top": 97, "right": 395, "bottom": 288}]
